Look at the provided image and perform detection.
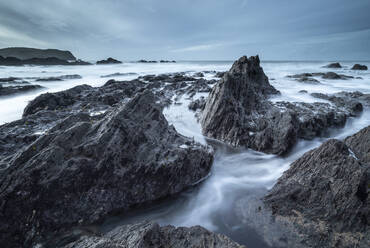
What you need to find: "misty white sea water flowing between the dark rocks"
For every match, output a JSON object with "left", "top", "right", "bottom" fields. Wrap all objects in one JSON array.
[{"left": 0, "top": 61, "right": 370, "bottom": 247}]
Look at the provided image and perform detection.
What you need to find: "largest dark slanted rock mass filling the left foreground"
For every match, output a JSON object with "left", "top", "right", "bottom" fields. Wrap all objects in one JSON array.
[{"left": 0, "top": 90, "right": 212, "bottom": 246}]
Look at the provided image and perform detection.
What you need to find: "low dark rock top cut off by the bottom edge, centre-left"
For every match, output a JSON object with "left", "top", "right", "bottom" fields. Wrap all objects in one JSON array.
[{"left": 57, "top": 222, "right": 245, "bottom": 248}]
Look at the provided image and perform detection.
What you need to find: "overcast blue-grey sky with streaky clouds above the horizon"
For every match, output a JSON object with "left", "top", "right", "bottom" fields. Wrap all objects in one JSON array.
[{"left": 0, "top": 0, "right": 370, "bottom": 61}]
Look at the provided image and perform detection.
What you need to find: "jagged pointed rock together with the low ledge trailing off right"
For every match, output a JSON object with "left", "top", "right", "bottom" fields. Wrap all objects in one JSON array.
[{"left": 199, "top": 56, "right": 369, "bottom": 155}]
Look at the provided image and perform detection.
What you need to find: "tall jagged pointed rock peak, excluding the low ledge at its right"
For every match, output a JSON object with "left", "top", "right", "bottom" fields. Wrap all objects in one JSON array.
[{"left": 201, "top": 56, "right": 304, "bottom": 154}]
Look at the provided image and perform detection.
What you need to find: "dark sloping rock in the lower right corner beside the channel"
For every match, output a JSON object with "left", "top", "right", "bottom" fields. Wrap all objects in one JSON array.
[{"left": 264, "top": 126, "right": 370, "bottom": 247}]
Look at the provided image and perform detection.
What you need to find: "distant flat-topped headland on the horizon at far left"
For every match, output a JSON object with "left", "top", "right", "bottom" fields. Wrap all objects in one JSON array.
[{"left": 0, "top": 47, "right": 76, "bottom": 60}]
